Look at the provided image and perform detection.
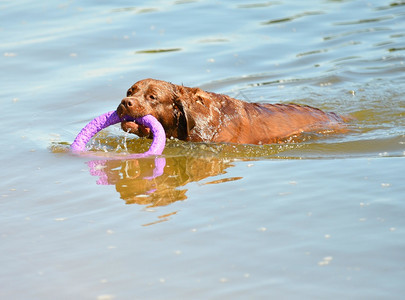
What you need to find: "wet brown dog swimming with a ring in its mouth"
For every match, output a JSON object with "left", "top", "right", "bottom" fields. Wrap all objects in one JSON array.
[{"left": 117, "top": 79, "right": 344, "bottom": 144}]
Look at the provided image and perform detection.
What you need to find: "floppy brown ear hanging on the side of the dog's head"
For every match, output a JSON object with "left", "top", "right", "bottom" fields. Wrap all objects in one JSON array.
[{"left": 174, "top": 86, "right": 196, "bottom": 140}]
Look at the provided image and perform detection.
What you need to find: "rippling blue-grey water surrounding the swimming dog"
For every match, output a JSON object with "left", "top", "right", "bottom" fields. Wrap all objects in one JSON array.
[{"left": 0, "top": 0, "right": 405, "bottom": 299}]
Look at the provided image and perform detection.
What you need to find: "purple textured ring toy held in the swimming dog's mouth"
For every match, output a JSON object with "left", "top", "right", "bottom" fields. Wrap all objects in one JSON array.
[{"left": 70, "top": 111, "right": 166, "bottom": 159}]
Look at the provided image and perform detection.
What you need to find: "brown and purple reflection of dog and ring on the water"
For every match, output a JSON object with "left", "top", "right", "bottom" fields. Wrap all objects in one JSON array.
[{"left": 88, "top": 156, "right": 241, "bottom": 207}]
